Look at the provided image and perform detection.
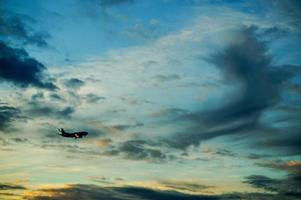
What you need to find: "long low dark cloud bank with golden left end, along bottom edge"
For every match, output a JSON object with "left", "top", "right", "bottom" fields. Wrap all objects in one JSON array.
[{"left": 23, "top": 184, "right": 299, "bottom": 200}]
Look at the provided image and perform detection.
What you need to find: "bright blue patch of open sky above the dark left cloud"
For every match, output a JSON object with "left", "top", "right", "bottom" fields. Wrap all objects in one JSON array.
[{"left": 6, "top": 0, "right": 199, "bottom": 65}]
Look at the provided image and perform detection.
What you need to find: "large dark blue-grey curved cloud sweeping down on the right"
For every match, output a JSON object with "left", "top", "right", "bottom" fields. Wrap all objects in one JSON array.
[{"left": 167, "top": 27, "right": 299, "bottom": 148}]
